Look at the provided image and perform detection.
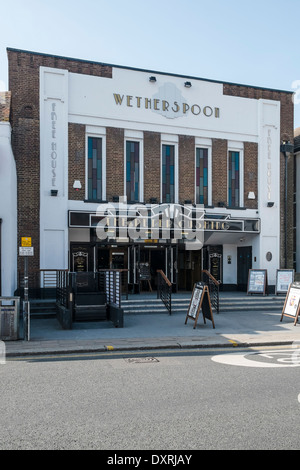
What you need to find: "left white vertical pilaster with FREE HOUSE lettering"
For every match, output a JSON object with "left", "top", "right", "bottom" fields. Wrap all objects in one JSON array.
[{"left": 40, "top": 67, "right": 69, "bottom": 269}]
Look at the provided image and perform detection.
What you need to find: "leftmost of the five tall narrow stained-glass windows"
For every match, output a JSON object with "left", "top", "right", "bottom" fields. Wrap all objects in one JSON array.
[{"left": 88, "top": 137, "right": 102, "bottom": 201}]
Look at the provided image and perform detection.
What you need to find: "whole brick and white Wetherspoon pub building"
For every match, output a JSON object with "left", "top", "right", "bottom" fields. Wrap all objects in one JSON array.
[{"left": 0, "top": 48, "right": 293, "bottom": 298}]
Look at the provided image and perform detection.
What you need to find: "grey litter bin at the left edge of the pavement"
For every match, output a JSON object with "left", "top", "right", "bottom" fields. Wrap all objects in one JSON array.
[{"left": 0, "top": 297, "right": 20, "bottom": 341}]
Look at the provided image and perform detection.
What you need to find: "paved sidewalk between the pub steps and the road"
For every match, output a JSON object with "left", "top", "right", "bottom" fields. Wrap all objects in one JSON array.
[{"left": 5, "top": 299, "right": 300, "bottom": 357}]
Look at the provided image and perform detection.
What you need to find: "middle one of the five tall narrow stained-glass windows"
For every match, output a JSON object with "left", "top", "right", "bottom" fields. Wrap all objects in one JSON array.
[{"left": 162, "top": 145, "right": 175, "bottom": 203}]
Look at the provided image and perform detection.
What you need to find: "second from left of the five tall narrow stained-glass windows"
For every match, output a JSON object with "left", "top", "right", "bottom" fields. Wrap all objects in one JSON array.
[{"left": 126, "top": 140, "right": 140, "bottom": 202}]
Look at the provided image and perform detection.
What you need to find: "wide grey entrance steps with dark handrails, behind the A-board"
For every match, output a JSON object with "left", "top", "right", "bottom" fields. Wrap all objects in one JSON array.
[{"left": 122, "top": 292, "right": 285, "bottom": 315}]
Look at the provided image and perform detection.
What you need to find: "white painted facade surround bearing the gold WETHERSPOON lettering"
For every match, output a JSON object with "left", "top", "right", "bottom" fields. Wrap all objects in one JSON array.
[{"left": 40, "top": 67, "right": 280, "bottom": 284}]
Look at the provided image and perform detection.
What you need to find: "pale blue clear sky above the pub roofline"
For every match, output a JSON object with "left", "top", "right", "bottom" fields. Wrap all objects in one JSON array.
[{"left": 0, "top": 0, "right": 300, "bottom": 128}]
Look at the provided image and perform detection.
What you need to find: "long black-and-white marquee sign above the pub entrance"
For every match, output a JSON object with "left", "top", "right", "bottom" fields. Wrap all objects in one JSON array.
[{"left": 69, "top": 203, "right": 260, "bottom": 241}]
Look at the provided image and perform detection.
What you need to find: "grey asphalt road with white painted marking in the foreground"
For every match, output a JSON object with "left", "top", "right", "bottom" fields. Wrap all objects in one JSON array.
[{"left": 0, "top": 348, "right": 300, "bottom": 452}]
